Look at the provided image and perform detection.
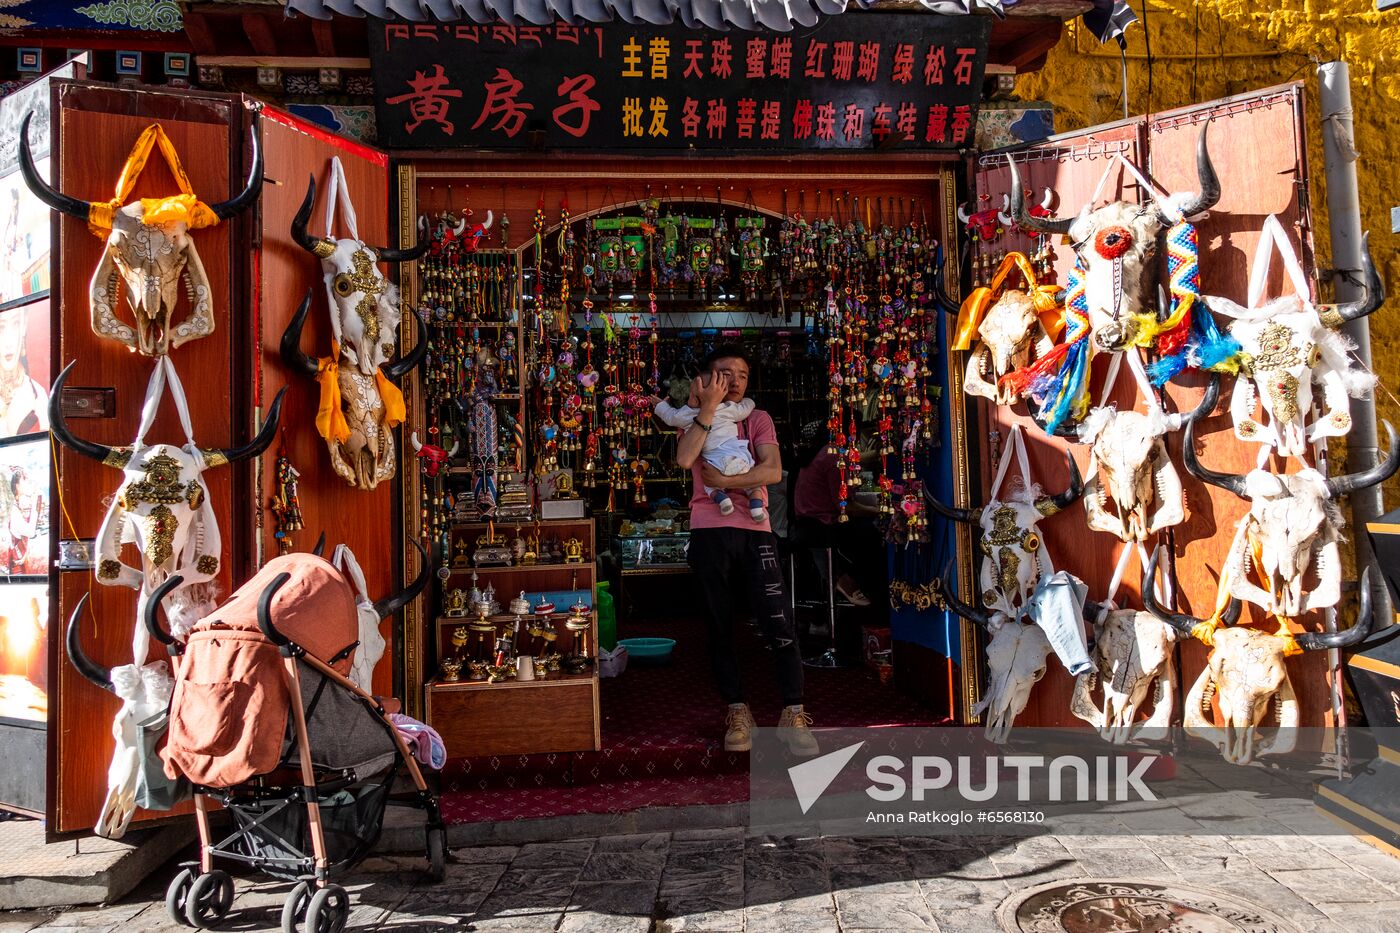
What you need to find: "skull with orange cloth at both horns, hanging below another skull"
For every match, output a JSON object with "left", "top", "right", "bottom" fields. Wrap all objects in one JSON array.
[{"left": 281, "top": 290, "right": 428, "bottom": 489}]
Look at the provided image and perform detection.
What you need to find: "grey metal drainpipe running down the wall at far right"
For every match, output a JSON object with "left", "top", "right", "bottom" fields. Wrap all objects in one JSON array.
[{"left": 1317, "top": 62, "right": 1394, "bottom": 625}]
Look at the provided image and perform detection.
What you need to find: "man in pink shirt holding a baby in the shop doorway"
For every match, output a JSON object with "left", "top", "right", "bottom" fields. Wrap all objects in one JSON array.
[{"left": 658, "top": 346, "right": 819, "bottom": 756}]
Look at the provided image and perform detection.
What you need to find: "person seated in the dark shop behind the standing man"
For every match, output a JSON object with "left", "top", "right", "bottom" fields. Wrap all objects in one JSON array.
[{"left": 792, "top": 422, "right": 889, "bottom": 608}]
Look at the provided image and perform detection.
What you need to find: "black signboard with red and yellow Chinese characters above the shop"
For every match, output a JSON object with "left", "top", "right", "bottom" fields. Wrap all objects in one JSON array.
[{"left": 370, "top": 13, "right": 991, "bottom": 150}]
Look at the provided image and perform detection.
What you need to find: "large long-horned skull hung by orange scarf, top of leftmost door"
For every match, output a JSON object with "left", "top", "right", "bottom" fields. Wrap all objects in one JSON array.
[{"left": 20, "top": 113, "right": 263, "bottom": 356}]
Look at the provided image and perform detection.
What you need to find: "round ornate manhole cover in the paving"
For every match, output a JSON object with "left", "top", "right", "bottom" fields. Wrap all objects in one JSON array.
[{"left": 997, "top": 878, "right": 1298, "bottom": 933}]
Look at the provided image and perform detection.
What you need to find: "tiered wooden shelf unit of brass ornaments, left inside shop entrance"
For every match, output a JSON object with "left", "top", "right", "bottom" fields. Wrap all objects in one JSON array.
[{"left": 426, "top": 518, "right": 601, "bottom": 756}]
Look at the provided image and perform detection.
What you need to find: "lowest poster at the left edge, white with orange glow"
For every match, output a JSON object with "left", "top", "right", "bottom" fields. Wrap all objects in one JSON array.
[{"left": 0, "top": 583, "right": 49, "bottom": 723}]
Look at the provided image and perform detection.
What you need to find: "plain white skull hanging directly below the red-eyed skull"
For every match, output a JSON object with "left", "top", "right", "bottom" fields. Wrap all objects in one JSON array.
[{"left": 1079, "top": 375, "right": 1219, "bottom": 541}]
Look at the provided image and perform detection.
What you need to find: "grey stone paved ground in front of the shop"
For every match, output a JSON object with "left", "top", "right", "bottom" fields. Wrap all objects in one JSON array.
[{"left": 0, "top": 824, "right": 1400, "bottom": 933}]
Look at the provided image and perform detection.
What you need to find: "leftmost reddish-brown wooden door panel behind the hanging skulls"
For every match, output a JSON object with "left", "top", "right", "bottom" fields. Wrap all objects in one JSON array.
[{"left": 46, "top": 83, "right": 251, "bottom": 834}]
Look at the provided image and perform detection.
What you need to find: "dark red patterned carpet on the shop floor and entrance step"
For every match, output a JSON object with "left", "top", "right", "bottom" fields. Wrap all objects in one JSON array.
[{"left": 442, "top": 619, "right": 941, "bottom": 822}]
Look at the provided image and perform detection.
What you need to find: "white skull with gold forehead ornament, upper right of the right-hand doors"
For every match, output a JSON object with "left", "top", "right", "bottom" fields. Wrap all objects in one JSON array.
[{"left": 1205, "top": 240, "right": 1386, "bottom": 457}]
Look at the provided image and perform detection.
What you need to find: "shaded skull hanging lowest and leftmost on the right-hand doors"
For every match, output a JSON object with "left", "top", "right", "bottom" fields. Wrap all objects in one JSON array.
[{"left": 944, "top": 574, "right": 1051, "bottom": 745}]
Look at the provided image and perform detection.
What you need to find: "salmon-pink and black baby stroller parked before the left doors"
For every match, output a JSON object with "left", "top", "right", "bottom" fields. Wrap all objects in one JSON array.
[{"left": 146, "top": 545, "right": 447, "bottom": 933}]
